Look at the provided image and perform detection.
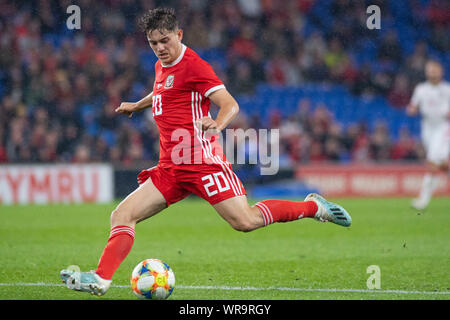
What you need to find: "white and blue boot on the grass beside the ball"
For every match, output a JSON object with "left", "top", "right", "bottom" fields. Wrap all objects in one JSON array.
[{"left": 59, "top": 269, "right": 112, "bottom": 296}]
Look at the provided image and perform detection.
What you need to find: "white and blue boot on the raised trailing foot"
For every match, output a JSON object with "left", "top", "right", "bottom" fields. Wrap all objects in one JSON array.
[{"left": 305, "top": 193, "right": 352, "bottom": 227}]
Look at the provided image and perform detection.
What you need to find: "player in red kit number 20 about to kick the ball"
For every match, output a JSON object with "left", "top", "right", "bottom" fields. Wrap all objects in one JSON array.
[{"left": 60, "top": 8, "right": 351, "bottom": 295}]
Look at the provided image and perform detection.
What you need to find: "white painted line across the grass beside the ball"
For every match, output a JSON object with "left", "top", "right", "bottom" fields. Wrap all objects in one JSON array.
[{"left": 0, "top": 282, "right": 450, "bottom": 295}]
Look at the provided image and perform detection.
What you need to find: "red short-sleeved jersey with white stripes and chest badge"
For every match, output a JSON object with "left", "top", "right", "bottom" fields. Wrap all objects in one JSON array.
[{"left": 152, "top": 44, "right": 226, "bottom": 166}]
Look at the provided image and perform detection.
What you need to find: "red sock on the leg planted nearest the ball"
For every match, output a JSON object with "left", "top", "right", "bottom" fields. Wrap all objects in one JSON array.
[{"left": 95, "top": 226, "right": 134, "bottom": 280}]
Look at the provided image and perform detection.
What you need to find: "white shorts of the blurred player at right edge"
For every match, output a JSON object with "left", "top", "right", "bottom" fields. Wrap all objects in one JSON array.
[{"left": 422, "top": 122, "right": 450, "bottom": 165}]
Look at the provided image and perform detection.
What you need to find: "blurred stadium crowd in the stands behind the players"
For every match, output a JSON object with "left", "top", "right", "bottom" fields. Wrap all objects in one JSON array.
[{"left": 0, "top": 0, "right": 450, "bottom": 166}]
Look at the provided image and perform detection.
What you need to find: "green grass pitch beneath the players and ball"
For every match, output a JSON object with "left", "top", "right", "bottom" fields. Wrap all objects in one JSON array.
[{"left": 0, "top": 198, "right": 450, "bottom": 300}]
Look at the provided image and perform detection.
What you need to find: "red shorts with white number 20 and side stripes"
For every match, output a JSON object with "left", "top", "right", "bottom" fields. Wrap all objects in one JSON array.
[{"left": 138, "top": 161, "right": 247, "bottom": 206}]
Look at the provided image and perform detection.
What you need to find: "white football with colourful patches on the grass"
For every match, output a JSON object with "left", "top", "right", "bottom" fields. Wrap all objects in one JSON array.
[{"left": 131, "top": 259, "right": 175, "bottom": 300}]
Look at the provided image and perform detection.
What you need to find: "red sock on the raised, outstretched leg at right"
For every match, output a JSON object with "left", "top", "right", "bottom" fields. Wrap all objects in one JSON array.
[{"left": 255, "top": 199, "right": 317, "bottom": 226}]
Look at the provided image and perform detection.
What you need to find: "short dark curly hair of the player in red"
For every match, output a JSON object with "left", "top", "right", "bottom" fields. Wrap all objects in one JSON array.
[{"left": 139, "top": 8, "right": 178, "bottom": 34}]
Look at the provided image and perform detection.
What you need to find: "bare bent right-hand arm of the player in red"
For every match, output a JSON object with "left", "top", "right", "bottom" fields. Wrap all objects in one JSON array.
[{"left": 198, "top": 88, "right": 239, "bottom": 132}]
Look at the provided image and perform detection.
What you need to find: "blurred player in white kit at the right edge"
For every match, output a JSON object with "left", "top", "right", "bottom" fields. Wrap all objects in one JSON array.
[{"left": 407, "top": 60, "right": 450, "bottom": 210}]
